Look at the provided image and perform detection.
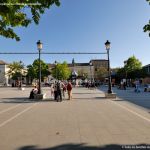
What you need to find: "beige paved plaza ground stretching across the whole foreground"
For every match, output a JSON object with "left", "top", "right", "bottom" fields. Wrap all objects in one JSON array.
[{"left": 0, "top": 87, "right": 150, "bottom": 150}]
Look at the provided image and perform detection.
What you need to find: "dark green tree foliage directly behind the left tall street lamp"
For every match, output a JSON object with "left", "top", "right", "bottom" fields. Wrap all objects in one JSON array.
[{"left": 27, "top": 59, "right": 50, "bottom": 80}]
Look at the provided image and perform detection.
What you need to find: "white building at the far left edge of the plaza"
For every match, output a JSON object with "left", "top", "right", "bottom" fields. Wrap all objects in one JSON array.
[{"left": 0, "top": 60, "right": 9, "bottom": 85}]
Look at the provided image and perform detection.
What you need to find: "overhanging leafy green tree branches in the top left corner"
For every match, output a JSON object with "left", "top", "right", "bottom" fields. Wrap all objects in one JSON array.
[{"left": 0, "top": 0, "right": 60, "bottom": 41}]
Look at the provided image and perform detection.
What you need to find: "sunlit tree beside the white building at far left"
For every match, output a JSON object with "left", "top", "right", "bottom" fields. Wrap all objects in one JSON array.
[{"left": 7, "top": 61, "right": 24, "bottom": 80}]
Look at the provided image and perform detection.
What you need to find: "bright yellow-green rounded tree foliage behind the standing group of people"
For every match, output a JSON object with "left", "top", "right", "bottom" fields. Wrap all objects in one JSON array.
[{"left": 52, "top": 62, "right": 71, "bottom": 80}]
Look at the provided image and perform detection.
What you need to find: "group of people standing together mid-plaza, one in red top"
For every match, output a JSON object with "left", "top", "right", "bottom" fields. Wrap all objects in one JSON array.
[{"left": 51, "top": 81, "right": 72, "bottom": 101}]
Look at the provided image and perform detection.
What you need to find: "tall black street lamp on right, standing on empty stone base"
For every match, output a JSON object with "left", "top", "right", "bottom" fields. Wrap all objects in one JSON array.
[{"left": 105, "top": 40, "right": 112, "bottom": 93}]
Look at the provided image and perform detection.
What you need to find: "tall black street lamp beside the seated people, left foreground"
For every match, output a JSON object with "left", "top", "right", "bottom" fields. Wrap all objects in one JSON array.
[{"left": 36, "top": 40, "right": 43, "bottom": 94}]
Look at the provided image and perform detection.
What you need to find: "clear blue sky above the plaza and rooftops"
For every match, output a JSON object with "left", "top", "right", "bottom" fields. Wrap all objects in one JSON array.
[{"left": 0, "top": 0, "right": 150, "bottom": 68}]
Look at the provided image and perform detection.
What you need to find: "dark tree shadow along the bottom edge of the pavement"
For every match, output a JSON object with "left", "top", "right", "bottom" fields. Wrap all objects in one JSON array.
[{"left": 17, "top": 144, "right": 150, "bottom": 150}]
